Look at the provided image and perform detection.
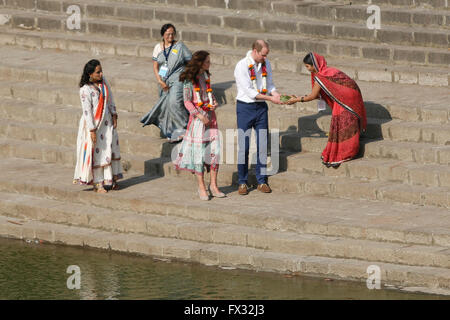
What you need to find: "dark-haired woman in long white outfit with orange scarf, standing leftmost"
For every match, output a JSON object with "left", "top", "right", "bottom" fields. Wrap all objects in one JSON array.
[{"left": 73, "top": 59, "right": 122, "bottom": 193}]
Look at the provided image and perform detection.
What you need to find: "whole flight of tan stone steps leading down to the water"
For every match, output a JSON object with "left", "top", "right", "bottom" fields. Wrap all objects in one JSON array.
[{"left": 0, "top": 0, "right": 450, "bottom": 294}]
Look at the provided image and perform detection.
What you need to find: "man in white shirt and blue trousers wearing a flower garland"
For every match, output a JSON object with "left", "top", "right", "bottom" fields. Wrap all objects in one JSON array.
[{"left": 234, "top": 40, "right": 281, "bottom": 195}]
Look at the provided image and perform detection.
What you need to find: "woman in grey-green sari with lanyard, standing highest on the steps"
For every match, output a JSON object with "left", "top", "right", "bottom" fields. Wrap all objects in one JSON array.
[{"left": 141, "top": 23, "right": 192, "bottom": 142}]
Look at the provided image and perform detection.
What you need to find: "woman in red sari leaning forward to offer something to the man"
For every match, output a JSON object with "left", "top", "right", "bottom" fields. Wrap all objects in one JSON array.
[{"left": 287, "top": 52, "right": 367, "bottom": 167}]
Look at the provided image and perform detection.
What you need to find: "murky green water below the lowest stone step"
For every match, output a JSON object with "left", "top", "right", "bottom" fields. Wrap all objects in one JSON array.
[{"left": 0, "top": 238, "right": 450, "bottom": 300}]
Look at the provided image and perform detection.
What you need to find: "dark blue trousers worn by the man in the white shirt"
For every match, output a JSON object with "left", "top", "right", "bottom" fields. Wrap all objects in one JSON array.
[{"left": 236, "top": 100, "right": 269, "bottom": 184}]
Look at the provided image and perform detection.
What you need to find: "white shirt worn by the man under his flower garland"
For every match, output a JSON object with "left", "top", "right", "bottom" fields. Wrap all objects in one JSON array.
[{"left": 234, "top": 51, "right": 276, "bottom": 103}]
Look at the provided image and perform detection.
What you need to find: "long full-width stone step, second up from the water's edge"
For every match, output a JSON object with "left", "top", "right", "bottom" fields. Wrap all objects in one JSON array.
[{"left": 0, "top": 192, "right": 450, "bottom": 268}]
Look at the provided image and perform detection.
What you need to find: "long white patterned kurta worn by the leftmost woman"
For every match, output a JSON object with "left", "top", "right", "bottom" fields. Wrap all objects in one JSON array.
[{"left": 74, "top": 79, "right": 122, "bottom": 184}]
